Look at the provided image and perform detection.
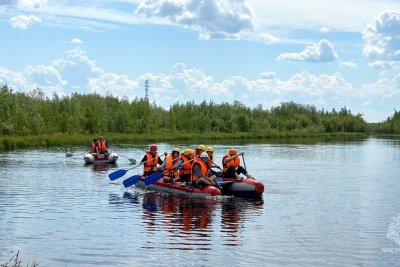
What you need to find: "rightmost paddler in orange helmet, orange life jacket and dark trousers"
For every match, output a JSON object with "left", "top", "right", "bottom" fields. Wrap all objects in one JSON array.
[{"left": 222, "top": 148, "right": 253, "bottom": 180}]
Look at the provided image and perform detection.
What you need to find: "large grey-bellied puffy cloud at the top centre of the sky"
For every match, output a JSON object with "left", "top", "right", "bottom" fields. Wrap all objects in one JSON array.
[{"left": 135, "top": 0, "right": 254, "bottom": 39}]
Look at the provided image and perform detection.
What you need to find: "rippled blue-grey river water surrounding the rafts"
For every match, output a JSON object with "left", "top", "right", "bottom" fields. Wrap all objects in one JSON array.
[{"left": 0, "top": 139, "right": 400, "bottom": 266}]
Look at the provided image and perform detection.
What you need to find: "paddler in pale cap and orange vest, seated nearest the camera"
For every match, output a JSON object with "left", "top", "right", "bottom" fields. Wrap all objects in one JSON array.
[{"left": 191, "top": 152, "right": 217, "bottom": 189}]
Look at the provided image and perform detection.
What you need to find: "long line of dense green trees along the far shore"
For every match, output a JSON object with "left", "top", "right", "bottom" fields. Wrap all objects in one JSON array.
[{"left": 0, "top": 85, "right": 400, "bottom": 136}]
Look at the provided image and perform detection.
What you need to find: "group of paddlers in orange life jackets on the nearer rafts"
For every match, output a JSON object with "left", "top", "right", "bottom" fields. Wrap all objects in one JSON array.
[{"left": 140, "top": 144, "right": 253, "bottom": 188}]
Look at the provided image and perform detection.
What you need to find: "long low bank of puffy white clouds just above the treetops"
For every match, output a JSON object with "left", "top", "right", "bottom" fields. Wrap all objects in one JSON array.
[{"left": 0, "top": 48, "right": 400, "bottom": 121}]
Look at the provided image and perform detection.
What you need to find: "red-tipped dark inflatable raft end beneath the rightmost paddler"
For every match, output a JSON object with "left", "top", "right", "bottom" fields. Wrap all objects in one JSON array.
[{"left": 217, "top": 178, "right": 264, "bottom": 198}]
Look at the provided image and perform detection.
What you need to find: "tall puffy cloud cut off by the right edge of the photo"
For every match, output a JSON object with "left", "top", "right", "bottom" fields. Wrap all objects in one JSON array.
[{"left": 362, "top": 10, "right": 400, "bottom": 61}]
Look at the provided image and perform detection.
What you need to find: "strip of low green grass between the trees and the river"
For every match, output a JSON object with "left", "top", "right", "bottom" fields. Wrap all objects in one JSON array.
[{"left": 0, "top": 131, "right": 368, "bottom": 151}]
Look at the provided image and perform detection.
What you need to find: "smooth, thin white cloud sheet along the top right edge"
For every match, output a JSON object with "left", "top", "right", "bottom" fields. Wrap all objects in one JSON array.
[{"left": 248, "top": 0, "right": 399, "bottom": 32}]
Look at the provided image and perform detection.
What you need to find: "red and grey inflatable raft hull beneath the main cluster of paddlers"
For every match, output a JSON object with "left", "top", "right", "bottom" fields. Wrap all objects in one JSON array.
[{"left": 136, "top": 178, "right": 221, "bottom": 197}]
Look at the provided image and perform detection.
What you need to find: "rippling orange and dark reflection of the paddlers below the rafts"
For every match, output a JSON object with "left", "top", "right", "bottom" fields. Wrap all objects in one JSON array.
[{"left": 109, "top": 192, "right": 263, "bottom": 250}]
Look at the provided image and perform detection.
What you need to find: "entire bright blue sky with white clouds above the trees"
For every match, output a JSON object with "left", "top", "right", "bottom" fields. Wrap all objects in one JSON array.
[{"left": 0, "top": 0, "right": 400, "bottom": 122}]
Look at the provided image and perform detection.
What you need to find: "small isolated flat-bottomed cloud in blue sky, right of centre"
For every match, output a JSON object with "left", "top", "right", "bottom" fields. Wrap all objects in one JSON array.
[{"left": 277, "top": 39, "right": 338, "bottom": 62}]
